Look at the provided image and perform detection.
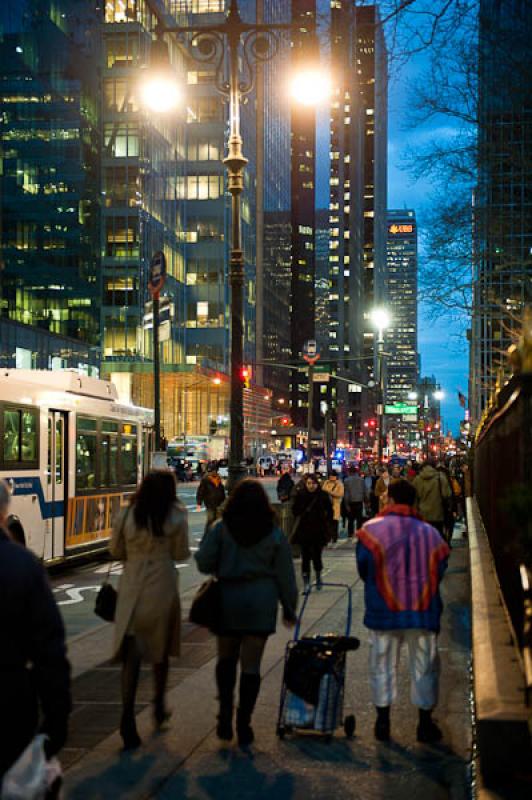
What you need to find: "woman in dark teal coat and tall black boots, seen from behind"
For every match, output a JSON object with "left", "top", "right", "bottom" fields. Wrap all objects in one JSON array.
[{"left": 195, "top": 478, "right": 297, "bottom": 746}]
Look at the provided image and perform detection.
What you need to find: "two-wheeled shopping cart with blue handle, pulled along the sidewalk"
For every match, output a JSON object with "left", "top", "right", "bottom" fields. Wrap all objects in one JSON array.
[{"left": 277, "top": 583, "right": 360, "bottom": 740}]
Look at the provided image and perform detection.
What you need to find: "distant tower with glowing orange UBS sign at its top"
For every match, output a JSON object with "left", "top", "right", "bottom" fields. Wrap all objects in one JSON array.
[{"left": 385, "top": 209, "right": 418, "bottom": 440}]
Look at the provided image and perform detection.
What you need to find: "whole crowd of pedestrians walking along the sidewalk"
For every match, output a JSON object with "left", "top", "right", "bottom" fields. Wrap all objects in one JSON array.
[{"left": 0, "top": 462, "right": 463, "bottom": 797}]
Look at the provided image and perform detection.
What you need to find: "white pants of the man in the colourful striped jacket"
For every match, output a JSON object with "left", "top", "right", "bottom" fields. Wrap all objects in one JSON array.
[{"left": 369, "top": 629, "right": 440, "bottom": 710}]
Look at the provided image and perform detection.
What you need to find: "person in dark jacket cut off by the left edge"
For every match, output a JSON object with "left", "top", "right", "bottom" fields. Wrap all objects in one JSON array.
[{"left": 0, "top": 481, "right": 71, "bottom": 782}]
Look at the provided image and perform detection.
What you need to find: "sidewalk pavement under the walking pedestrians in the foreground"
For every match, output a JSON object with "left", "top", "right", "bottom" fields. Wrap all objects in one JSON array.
[{"left": 63, "top": 538, "right": 472, "bottom": 800}]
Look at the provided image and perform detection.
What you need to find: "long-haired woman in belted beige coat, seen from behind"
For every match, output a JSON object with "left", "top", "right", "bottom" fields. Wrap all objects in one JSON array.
[{"left": 110, "top": 471, "right": 190, "bottom": 749}]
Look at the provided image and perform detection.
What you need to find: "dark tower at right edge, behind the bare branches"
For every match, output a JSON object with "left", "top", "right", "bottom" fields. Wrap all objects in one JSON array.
[{"left": 470, "top": 0, "right": 532, "bottom": 422}]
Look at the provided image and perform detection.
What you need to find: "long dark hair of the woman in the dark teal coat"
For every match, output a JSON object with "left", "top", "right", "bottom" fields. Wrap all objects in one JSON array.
[{"left": 223, "top": 478, "right": 275, "bottom": 547}]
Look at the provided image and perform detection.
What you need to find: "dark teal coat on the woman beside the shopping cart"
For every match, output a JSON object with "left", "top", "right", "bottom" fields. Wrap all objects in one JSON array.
[{"left": 194, "top": 520, "right": 297, "bottom": 636}]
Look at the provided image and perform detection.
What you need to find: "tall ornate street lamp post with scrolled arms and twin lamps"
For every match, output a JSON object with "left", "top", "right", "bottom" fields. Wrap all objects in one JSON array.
[{"left": 141, "top": 0, "right": 328, "bottom": 486}]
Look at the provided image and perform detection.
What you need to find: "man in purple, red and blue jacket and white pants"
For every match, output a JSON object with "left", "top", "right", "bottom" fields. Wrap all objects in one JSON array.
[{"left": 356, "top": 479, "right": 449, "bottom": 742}]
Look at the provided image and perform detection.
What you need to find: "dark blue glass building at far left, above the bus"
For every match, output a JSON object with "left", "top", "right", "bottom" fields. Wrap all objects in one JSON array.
[{"left": 0, "top": 0, "right": 100, "bottom": 369}]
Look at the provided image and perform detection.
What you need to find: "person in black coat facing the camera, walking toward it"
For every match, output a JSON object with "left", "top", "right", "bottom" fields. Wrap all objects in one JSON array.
[{"left": 291, "top": 473, "right": 333, "bottom": 592}]
